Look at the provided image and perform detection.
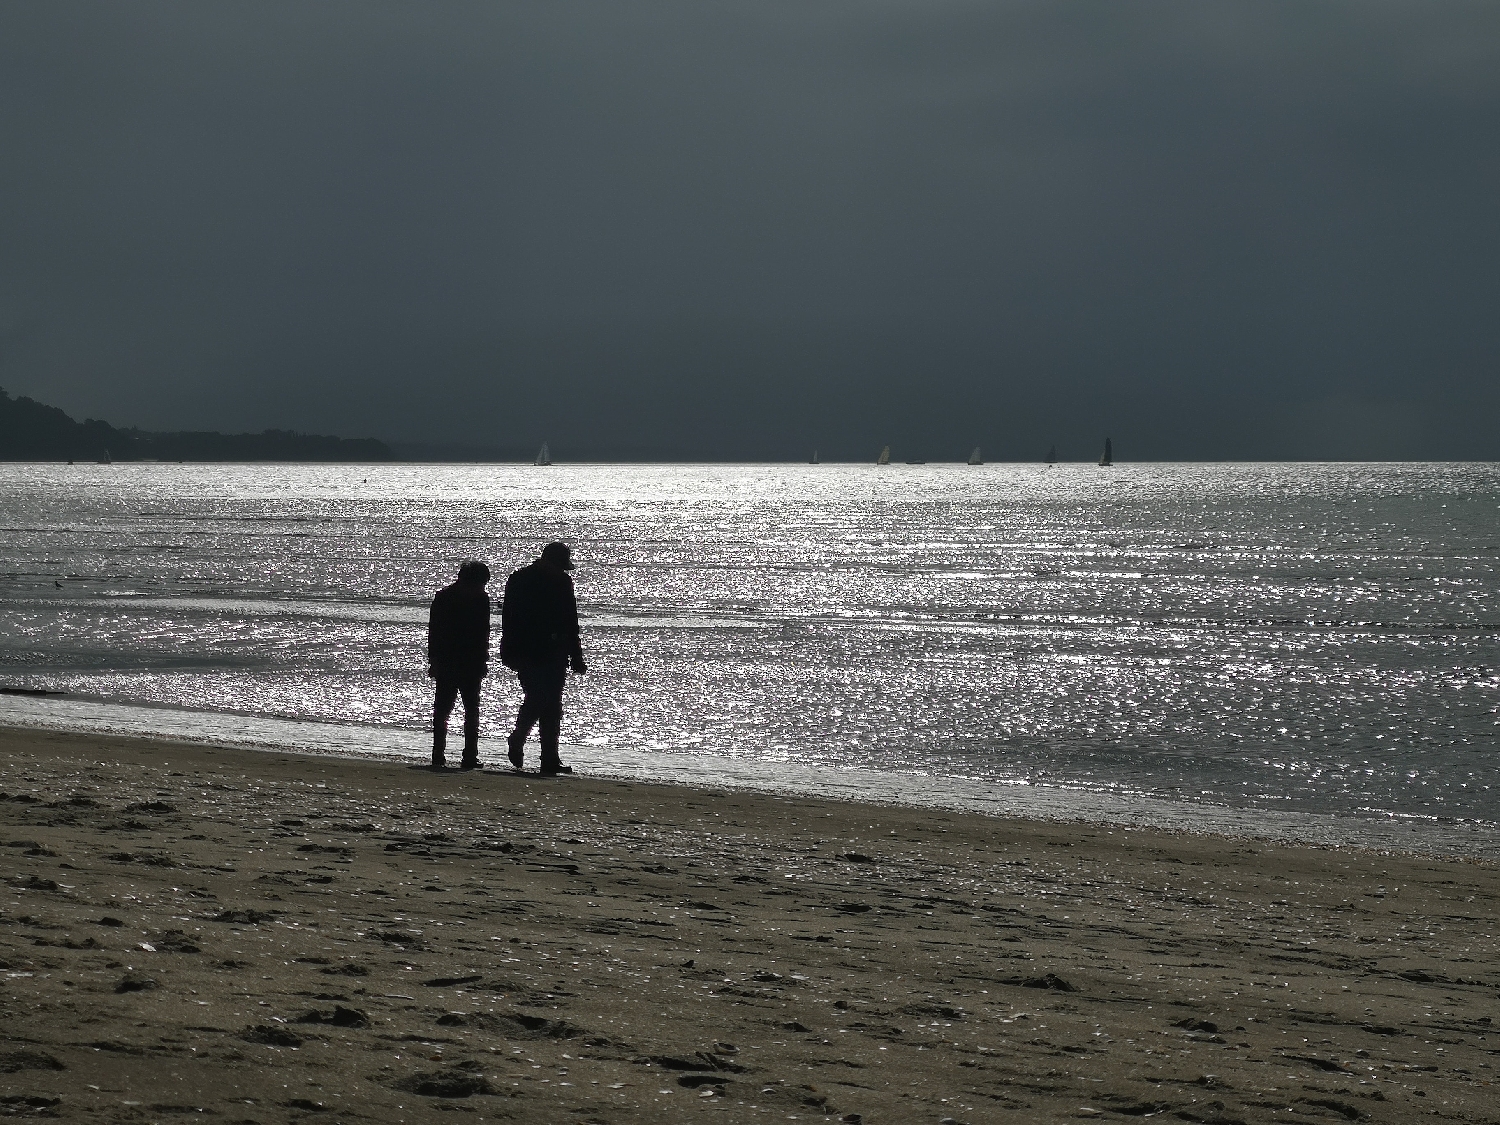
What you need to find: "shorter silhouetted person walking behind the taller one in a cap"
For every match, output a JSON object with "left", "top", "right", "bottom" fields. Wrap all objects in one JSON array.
[{"left": 428, "top": 560, "right": 489, "bottom": 770}]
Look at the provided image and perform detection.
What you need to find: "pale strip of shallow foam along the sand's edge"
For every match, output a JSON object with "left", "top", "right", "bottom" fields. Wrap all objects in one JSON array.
[{"left": 0, "top": 696, "right": 1500, "bottom": 857}]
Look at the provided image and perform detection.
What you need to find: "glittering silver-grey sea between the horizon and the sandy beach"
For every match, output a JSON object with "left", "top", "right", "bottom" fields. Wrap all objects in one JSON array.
[{"left": 0, "top": 464, "right": 1500, "bottom": 855}]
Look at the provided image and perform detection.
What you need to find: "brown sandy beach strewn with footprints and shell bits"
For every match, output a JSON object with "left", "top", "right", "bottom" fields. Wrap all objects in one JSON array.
[{"left": 0, "top": 731, "right": 1500, "bottom": 1125}]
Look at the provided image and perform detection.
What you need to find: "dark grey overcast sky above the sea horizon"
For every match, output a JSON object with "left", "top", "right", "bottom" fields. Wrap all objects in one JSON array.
[{"left": 0, "top": 0, "right": 1500, "bottom": 459}]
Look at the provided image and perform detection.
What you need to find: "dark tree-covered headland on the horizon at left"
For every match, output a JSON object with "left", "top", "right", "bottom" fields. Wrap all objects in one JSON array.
[{"left": 0, "top": 389, "right": 396, "bottom": 461}]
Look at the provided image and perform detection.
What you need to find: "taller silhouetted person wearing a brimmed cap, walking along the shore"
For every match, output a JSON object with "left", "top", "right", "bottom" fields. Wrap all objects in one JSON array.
[{"left": 500, "top": 543, "right": 588, "bottom": 774}]
